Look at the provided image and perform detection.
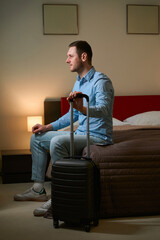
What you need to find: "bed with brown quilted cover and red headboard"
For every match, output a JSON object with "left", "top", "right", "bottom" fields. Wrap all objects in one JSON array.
[{"left": 44, "top": 95, "right": 160, "bottom": 218}]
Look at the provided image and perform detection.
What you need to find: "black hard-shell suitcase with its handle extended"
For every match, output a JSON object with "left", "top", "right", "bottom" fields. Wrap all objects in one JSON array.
[{"left": 51, "top": 94, "right": 100, "bottom": 232}]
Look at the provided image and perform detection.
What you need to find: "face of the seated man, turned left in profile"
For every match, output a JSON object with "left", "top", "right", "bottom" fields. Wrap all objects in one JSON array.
[{"left": 66, "top": 47, "right": 83, "bottom": 73}]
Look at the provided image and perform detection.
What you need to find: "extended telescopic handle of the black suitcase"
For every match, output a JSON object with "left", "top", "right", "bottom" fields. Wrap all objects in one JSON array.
[{"left": 70, "top": 93, "right": 90, "bottom": 158}]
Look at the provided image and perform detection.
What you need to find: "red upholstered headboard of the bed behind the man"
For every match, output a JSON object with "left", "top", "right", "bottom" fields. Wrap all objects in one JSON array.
[{"left": 61, "top": 95, "right": 160, "bottom": 121}]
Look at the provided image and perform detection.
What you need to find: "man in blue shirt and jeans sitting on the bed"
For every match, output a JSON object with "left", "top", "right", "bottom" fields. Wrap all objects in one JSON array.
[{"left": 14, "top": 41, "right": 114, "bottom": 216}]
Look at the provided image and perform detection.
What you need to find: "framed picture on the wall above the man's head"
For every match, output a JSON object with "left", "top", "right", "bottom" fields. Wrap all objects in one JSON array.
[{"left": 42, "top": 4, "right": 78, "bottom": 35}]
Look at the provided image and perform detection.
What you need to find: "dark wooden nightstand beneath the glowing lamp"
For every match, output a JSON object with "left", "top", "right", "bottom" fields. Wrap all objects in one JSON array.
[{"left": 1, "top": 150, "right": 32, "bottom": 183}]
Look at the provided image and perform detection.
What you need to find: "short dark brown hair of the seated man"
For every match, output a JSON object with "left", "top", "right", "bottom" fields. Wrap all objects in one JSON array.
[{"left": 69, "top": 40, "right": 93, "bottom": 64}]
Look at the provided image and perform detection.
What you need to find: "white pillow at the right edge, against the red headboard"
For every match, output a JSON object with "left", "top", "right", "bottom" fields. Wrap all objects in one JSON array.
[{"left": 123, "top": 111, "right": 160, "bottom": 125}]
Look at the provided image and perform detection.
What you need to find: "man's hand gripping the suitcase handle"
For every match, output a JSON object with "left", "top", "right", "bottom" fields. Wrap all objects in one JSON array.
[{"left": 67, "top": 91, "right": 86, "bottom": 115}]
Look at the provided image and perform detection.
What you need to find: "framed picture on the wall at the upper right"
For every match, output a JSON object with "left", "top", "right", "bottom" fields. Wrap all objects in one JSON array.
[{"left": 126, "top": 4, "right": 159, "bottom": 34}]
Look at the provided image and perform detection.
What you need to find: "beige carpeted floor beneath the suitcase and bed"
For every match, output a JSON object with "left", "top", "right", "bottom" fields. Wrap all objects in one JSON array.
[{"left": 0, "top": 182, "right": 160, "bottom": 240}]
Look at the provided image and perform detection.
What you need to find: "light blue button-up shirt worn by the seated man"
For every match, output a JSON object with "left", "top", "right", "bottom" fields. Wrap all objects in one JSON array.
[{"left": 51, "top": 67, "right": 114, "bottom": 144}]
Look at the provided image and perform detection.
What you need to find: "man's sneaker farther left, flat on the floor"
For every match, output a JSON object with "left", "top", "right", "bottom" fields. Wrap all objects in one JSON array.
[{"left": 14, "top": 188, "right": 48, "bottom": 202}]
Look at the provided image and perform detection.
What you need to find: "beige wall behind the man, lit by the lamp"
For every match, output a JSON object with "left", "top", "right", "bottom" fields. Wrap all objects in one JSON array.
[{"left": 0, "top": 0, "right": 160, "bottom": 149}]
